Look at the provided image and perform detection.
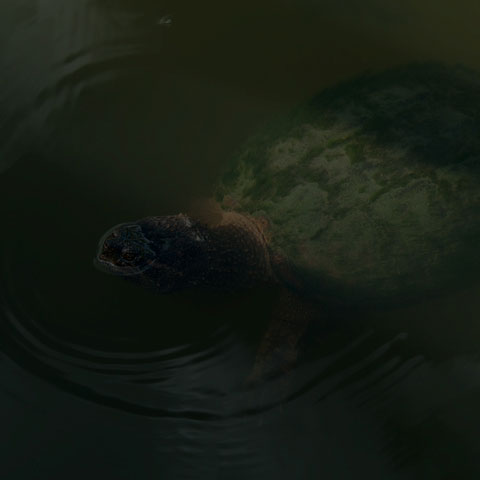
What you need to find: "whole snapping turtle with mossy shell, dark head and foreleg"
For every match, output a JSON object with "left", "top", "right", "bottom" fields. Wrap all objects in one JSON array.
[{"left": 97, "top": 64, "right": 480, "bottom": 379}]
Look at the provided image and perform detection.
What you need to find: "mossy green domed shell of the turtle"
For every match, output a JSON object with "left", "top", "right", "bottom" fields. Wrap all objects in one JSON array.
[{"left": 216, "top": 64, "right": 480, "bottom": 301}]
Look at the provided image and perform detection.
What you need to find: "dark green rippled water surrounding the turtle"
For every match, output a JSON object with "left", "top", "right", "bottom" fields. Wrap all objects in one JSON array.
[{"left": 0, "top": 0, "right": 480, "bottom": 480}]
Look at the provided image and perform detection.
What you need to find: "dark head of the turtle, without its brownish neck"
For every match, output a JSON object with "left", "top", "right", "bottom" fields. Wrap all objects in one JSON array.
[{"left": 95, "top": 214, "right": 208, "bottom": 293}]
